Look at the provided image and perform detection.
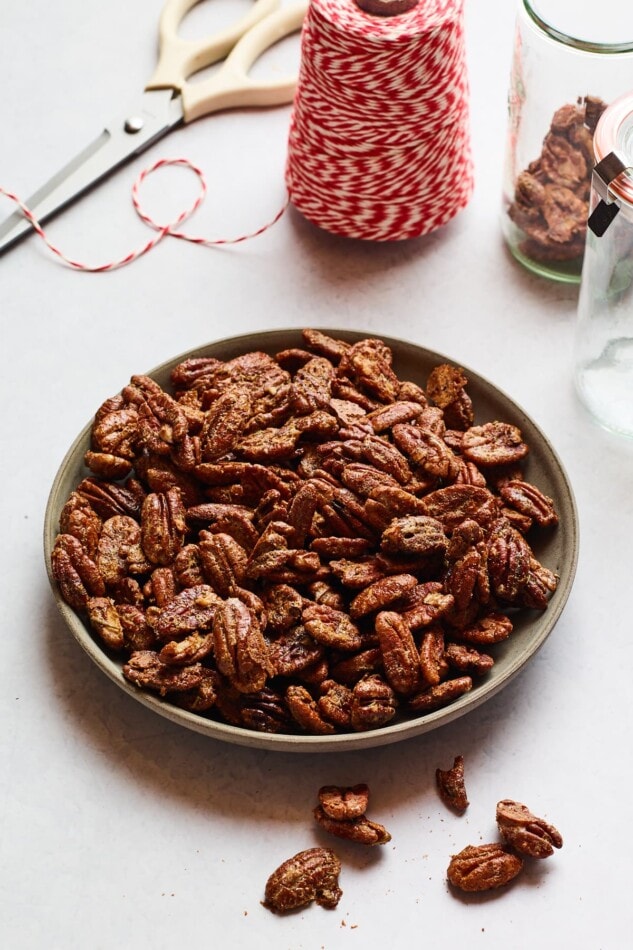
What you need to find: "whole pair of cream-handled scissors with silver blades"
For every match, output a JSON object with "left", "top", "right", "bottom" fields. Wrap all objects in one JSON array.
[{"left": 0, "top": 0, "right": 307, "bottom": 254}]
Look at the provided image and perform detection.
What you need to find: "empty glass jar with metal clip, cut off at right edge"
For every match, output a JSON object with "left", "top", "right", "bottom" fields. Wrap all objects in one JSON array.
[{"left": 575, "top": 93, "right": 633, "bottom": 436}]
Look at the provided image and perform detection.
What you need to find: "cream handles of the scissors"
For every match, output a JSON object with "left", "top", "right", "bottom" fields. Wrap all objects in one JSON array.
[{"left": 145, "top": 0, "right": 307, "bottom": 122}]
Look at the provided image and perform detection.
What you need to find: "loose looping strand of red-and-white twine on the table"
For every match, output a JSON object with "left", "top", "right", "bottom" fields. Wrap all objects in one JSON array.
[{"left": 0, "top": 158, "right": 288, "bottom": 273}]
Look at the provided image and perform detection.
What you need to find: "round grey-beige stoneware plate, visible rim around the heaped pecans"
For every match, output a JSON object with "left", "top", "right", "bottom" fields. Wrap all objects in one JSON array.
[{"left": 44, "top": 329, "right": 578, "bottom": 752}]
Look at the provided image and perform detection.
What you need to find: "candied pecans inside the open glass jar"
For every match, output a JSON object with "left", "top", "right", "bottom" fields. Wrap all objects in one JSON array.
[{"left": 508, "top": 96, "right": 606, "bottom": 263}]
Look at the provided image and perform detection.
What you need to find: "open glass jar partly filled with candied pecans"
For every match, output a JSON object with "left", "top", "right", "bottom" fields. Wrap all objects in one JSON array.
[{"left": 502, "top": 0, "right": 633, "bottom": 283}]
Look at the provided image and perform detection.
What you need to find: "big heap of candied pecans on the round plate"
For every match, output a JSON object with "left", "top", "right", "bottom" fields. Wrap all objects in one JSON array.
[{"left": 51, "top": 330, "right": 558, "bottom": 736}]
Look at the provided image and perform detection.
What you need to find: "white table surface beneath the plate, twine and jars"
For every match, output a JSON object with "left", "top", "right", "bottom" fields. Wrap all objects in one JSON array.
[{"left": 0, "top": 0, "right": 633, "bottom": 950}]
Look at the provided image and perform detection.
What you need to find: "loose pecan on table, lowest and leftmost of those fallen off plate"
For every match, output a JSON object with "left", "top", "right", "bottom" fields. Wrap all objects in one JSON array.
[{"left": 262, "top": 848, "right": 343, "bottom": 914}]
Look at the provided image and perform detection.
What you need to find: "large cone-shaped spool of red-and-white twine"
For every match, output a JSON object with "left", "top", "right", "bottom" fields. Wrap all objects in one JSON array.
[{"left": 286, "top": 0, "right": 473, "bottom": 241}]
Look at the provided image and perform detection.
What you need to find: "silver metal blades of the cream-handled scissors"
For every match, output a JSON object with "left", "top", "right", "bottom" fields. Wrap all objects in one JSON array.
[{"left": 0, "top": 89, "right": 183, "bottom": 254}]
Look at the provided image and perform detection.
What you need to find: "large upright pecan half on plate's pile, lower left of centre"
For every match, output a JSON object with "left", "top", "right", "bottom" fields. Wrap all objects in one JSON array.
[{"left": 213, "top": 597, "right": 271, "bottom": 693}]
